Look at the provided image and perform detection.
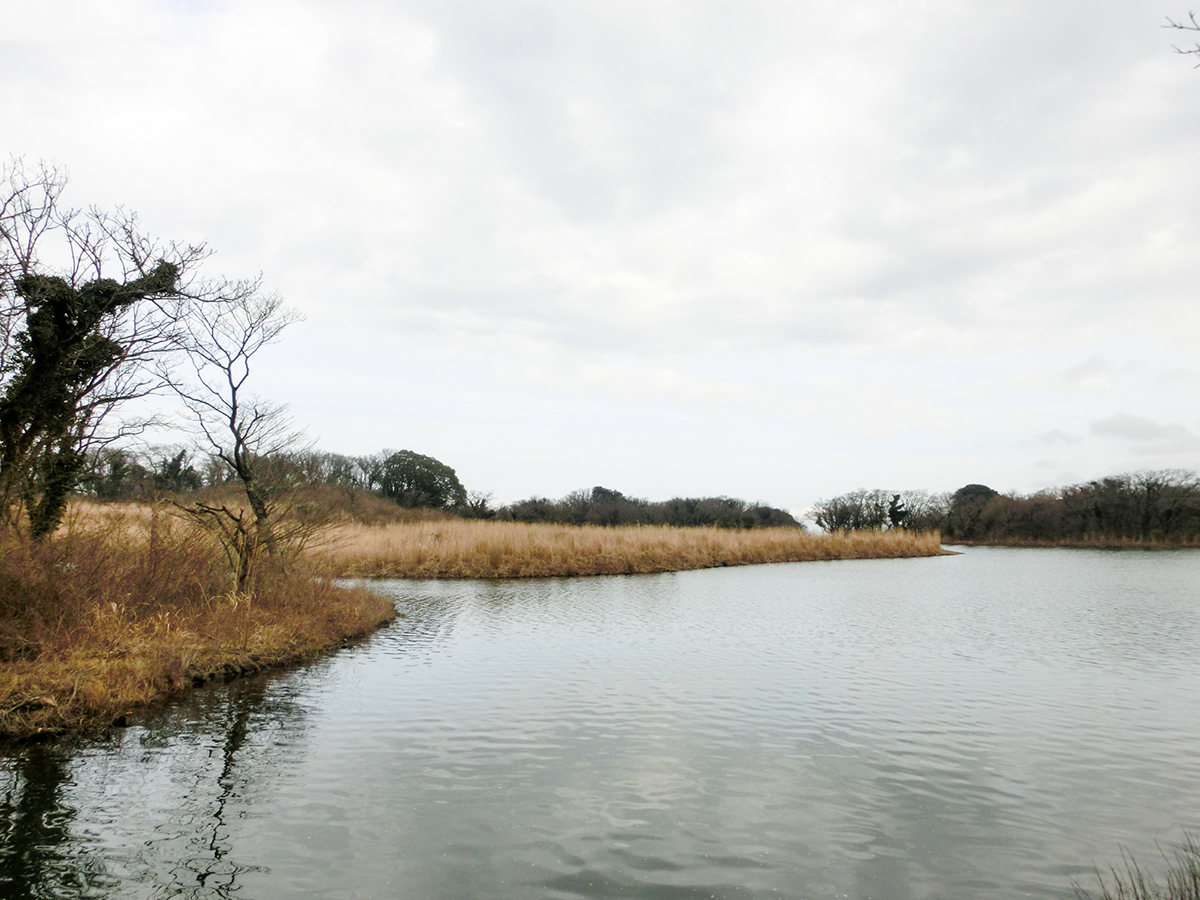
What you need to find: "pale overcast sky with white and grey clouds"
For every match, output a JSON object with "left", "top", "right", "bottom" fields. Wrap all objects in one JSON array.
[{"left": 0, "top": 0, "right": 1200, "bottom": 511}]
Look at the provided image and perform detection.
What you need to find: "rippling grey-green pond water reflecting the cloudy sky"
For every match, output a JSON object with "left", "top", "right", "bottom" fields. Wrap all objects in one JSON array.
[{"left": 0, "top": 548, "right": 1200, "bottom": 900}]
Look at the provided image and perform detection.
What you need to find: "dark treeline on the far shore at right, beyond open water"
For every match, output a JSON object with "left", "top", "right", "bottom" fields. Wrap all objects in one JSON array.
[{"left": 812, "top": 469, "right": 1200, "bottom": 544}]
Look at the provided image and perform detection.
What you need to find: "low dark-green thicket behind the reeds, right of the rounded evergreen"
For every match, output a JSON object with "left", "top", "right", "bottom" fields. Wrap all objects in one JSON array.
[{"left": 498, "top": 487, "right": 799, "bottom": 528}]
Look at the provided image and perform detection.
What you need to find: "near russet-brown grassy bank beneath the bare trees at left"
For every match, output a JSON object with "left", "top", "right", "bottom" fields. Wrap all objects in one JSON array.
[{"left": 0, "top": 508, "right": 395, "bottom": 739}]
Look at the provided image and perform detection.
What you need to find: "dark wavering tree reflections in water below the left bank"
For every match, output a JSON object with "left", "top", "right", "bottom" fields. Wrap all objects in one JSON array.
[{"left": 0, "top": 676, "right": 304, "bottom": 900}]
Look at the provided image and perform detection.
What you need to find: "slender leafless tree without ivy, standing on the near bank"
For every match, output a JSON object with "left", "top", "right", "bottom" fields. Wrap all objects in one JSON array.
[{"left": 163, "top": 285, "right": 307, "bottom": 590}]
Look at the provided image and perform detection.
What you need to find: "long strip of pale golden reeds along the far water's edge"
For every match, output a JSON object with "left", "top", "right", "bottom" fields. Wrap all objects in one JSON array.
[{"left": 320, "top": 520, "right": 942, "bottom": 578}]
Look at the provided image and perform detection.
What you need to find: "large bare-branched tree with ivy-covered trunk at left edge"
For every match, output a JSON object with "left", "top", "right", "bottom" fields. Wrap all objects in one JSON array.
[{"left": 0, "top": 158, "right": 209, "bottom": 538}]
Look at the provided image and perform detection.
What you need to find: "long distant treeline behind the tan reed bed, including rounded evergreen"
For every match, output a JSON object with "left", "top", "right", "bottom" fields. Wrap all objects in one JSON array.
[{"left": 85, "top": 448, "right": 800, "bottom": 528}]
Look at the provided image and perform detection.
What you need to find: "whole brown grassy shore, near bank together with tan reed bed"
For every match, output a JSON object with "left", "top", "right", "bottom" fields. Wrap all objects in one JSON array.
[{"left": 0, "top": 518, "right": 946, "bottom": 748}]
